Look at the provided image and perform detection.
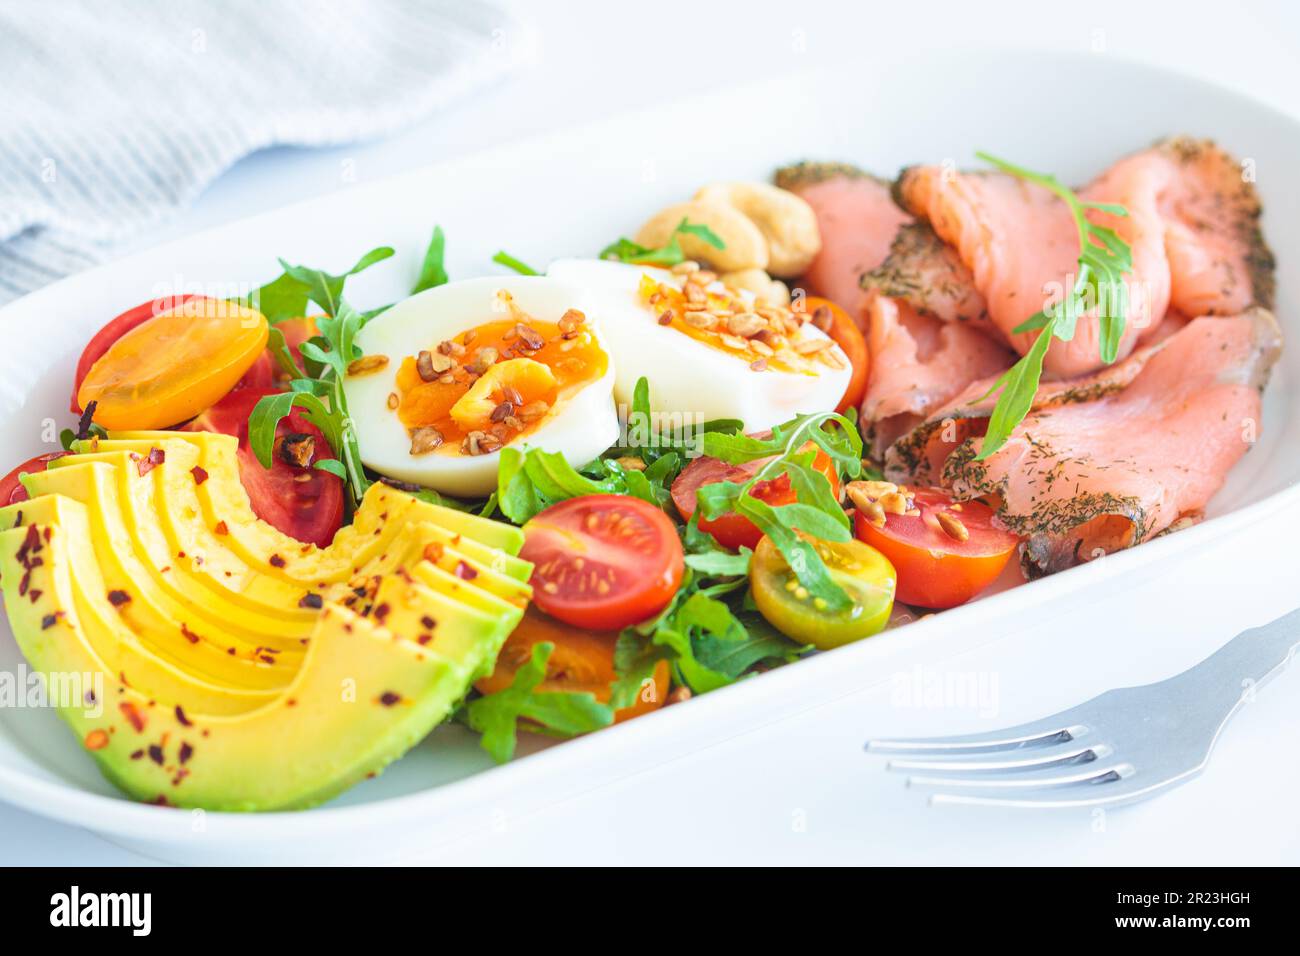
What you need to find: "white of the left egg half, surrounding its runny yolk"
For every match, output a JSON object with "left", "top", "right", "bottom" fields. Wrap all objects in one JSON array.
[{"left": 343, "top": 276, "right": 619, "bottom": 497}]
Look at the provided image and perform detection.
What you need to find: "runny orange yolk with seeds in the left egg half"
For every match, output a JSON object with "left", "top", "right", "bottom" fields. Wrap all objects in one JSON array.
[{"left": 389, "top": 306, "right": 608, "bottom": 455}]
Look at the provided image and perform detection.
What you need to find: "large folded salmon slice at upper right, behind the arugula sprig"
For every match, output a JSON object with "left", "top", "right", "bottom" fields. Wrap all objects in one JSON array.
[{"left": 897, "top": 138, "right": 1273, "bottom": 377}]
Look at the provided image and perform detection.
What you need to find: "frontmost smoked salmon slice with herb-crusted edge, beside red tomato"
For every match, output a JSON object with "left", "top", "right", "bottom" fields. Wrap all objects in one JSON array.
[{"left": 885, "top": 307, "right": 1282, "bottom": 578}]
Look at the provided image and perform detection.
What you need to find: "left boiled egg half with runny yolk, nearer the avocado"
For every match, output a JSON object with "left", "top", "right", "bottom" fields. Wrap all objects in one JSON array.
[{"left": 343, "top": 276, "right": 619, "bottom": 496}]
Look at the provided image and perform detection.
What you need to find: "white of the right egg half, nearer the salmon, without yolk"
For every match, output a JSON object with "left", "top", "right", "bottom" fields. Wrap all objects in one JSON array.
[{"left": 547, "top": 259, "right": 853, "bottom": 431}]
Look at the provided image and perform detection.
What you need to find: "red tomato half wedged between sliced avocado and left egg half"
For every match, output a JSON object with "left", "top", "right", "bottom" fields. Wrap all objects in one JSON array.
[{"left": 187, "top": 389, "right": 343, "bottom": 548}]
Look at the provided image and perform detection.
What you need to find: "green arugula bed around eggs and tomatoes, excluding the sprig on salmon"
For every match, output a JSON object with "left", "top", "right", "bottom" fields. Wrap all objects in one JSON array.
[{"left": 231, "top": 227, "right": 862, "bottom": 761}]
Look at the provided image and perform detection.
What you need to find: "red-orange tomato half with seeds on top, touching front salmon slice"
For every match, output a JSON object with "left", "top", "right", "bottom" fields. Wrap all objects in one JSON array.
[{"left": 855, "top": 490, "right": 1021, "bottom": 609}]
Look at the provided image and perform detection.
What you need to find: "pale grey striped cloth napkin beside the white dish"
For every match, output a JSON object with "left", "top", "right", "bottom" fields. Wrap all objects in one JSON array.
[{"left": 0, "top": 0, "right": 521, "bottom": 304}]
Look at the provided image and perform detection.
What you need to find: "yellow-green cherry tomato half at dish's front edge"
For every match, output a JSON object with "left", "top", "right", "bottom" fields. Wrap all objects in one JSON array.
[{"left": 749, "top": 536, "right": 897, "bottom": 650}]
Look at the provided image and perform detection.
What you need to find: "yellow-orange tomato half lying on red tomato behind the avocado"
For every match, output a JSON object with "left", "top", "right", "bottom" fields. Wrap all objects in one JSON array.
[{"left": 77, "top": 298, "right": 268, "bottom": 429}]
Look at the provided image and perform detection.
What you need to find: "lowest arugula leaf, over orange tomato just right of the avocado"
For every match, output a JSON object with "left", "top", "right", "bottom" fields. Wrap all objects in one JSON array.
[{"left": 465, "top": 641, "right": 614, "bottom": 763}]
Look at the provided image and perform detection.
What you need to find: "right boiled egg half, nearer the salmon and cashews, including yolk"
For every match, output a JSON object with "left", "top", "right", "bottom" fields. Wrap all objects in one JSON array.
[{"left": 547, "top": 259, "right": 853, "bottom": 432}]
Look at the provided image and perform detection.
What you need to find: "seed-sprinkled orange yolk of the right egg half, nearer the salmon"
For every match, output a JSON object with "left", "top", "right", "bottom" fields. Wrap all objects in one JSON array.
[{"left": 638, "top": 276, "right": 818, "bottom": 375}]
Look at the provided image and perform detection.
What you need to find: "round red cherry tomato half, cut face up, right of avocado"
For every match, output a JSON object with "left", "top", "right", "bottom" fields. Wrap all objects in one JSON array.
[{"left": 520, "top": 494, "right": 685, "bottom": 631}]
